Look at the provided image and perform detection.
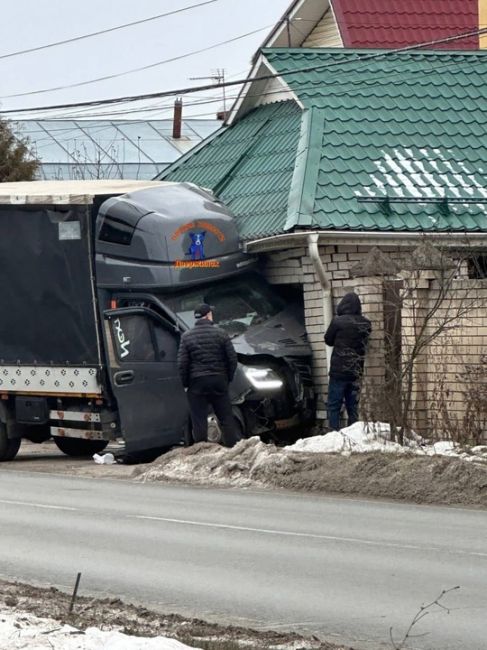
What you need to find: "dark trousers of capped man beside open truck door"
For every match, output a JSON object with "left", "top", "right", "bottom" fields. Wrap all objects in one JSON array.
[{"left": 188, "top": 375, "right": 238, "bottom": 447}]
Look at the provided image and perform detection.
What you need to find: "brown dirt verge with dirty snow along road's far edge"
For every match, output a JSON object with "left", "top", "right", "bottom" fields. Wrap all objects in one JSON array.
[{"left": 1, "top": 438, "right": 487, "bottom": 508}]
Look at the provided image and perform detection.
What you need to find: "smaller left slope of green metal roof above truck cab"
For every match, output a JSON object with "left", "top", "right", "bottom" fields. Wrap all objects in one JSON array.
[{"left": 160, "top": 101, "right": 301, "bottom": 239}]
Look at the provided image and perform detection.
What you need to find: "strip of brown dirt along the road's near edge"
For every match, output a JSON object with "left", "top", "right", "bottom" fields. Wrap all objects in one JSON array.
[{"left": 0, "top": 580, "right": 353, "bottom": 650}]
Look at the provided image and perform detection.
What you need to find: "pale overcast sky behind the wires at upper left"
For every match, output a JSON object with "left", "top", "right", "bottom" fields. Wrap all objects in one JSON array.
[{"left": 0, "top": 0, "right": 290, "bottom": 119}]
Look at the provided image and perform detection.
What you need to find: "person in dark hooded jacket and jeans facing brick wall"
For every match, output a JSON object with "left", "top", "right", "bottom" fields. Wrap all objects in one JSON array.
[{"left": 325, "top": 293, "right": 372, "bottom": 431}]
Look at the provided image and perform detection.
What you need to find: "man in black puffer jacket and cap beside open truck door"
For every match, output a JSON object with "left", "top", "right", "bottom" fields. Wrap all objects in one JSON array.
[{"left": 178, "top": 304, "right": 238, "bottom": 447}]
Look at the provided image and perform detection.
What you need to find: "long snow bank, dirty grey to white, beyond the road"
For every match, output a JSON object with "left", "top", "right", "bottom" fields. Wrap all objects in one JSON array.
[{"left": 132, "top": 422, "right": 487, "bottom": 490}]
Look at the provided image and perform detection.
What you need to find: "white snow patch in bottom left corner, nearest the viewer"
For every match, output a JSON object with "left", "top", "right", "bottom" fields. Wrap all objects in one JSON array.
[{"left": 0, "top": 608, "right": 196, "bottom": 650}]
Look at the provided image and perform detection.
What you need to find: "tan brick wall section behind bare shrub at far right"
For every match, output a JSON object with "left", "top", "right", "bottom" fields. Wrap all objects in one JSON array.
[{"left": 403, "top": 279, "right": 487, "bottom": 440}]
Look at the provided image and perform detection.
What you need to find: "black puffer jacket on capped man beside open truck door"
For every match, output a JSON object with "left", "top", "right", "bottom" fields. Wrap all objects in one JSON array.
[{"left": 178, "top": 318, "right": 237, "bottom": 388}]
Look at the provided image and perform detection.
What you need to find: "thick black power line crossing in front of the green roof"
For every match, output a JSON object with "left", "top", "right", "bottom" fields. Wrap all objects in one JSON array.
[{"left": 0, "top": 28, "right": 487, "bottom": 115}]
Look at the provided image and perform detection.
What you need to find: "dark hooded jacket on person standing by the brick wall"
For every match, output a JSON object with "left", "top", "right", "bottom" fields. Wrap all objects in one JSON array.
[{"left": 325, "top": 293, "right": 372, "bottom": 381}]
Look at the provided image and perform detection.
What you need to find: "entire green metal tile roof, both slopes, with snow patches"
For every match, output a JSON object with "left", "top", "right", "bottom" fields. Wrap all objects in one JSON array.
[{"left": 165, "top": 49, "right": 487, "bottom": 239}]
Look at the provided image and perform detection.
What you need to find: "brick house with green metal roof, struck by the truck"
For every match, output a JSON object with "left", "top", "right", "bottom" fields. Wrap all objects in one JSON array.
[{"left": 161, "top": 48, "right": 487, "bottom": 436}]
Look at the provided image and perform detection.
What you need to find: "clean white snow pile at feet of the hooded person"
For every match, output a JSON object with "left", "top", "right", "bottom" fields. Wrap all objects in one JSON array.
[{"left": 286, "top": 422, "right": 487, "bottom": 462}]
